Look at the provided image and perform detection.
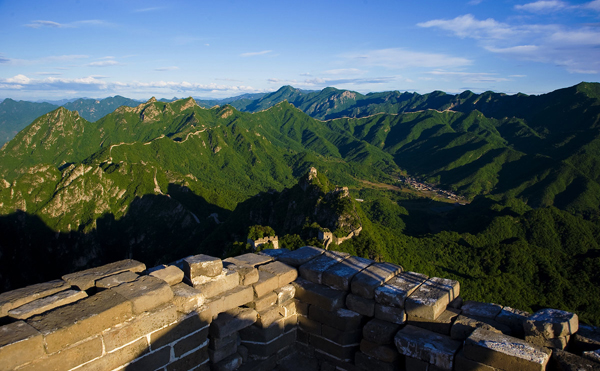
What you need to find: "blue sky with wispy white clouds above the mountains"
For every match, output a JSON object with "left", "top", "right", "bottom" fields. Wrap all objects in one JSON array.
[{"left": 0, "top": 0, "right": 600, "bottom": 100}]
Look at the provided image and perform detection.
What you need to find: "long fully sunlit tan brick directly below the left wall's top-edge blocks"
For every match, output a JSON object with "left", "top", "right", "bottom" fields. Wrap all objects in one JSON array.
[{"left": 102, "top": 304, "right": 177, "bottom": 352}]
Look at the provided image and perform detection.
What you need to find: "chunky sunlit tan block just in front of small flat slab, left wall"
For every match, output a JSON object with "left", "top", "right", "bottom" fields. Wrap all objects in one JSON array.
[{"left": 110, "top": 276, "right": 173, "bottom": 314}]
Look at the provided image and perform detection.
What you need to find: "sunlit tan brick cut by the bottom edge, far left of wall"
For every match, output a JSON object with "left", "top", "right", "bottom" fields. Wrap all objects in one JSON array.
[{"left": 15, "top": 336, "right": 102, "bottom": 371}]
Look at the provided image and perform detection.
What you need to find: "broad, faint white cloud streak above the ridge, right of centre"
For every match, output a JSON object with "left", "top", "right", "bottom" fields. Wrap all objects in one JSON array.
[{"left": 344, "top": 48, "right": 472, "bottom": 69}]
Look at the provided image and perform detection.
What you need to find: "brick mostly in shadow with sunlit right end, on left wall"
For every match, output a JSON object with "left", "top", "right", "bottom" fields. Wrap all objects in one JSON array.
[{"left": 150, "top": 307, "right": 212, "bottom": 350}]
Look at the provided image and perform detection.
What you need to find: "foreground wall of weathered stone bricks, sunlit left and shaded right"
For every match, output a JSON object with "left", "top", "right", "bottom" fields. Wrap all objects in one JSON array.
[{"left": 0, "top": 246, "right": 600, "bottom": 371}]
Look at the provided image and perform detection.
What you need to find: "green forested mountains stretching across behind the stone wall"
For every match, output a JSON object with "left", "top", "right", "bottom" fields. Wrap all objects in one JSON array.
[{"left": 0, "top": 83, "right": 600, "bottom": 323}]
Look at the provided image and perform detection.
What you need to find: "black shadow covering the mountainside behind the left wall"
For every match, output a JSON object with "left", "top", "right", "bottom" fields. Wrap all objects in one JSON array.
[{"left": 0, "top": 184, "right": 229, "bottom": 292}]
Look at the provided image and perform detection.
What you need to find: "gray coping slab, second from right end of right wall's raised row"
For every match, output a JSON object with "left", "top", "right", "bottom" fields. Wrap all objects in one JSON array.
[{"left": 375, "top": 272, "right": 429, "bottom": 308}]
